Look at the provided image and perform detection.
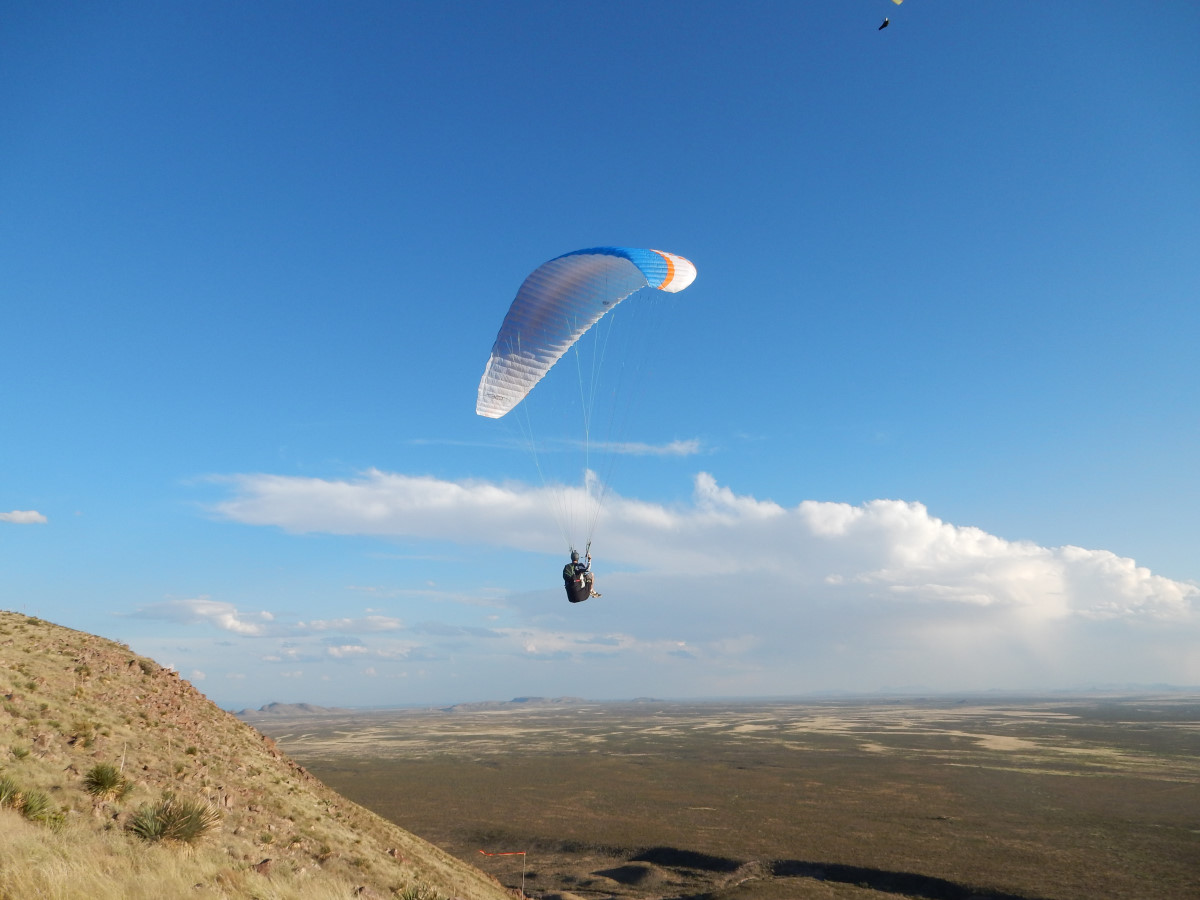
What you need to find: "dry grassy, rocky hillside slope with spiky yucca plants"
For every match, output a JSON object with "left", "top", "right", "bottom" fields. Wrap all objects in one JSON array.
[{"left": 0, "top": 611, "right": 511, "bottom": 900}]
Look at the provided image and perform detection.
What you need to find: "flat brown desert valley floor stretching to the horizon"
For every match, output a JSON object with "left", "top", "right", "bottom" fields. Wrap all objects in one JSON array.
[{"left": 246, "top": 695, "right": 1200, "bottom": 900}]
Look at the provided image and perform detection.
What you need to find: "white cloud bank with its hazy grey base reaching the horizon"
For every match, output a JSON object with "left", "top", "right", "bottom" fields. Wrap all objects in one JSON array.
[{"left": 159, "top": 469, "right": 1200, "bottom": 701}]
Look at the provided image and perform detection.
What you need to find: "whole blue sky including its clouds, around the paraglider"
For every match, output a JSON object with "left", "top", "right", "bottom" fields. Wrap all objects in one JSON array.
[{"left": 0, "top": 0, "right": 1200, "bottom": 707}]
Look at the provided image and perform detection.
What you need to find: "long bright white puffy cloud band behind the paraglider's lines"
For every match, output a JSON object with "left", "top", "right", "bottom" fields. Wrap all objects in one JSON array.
[{"left": 217, "top": 469, "right": 1200, "bottom": 628}]
